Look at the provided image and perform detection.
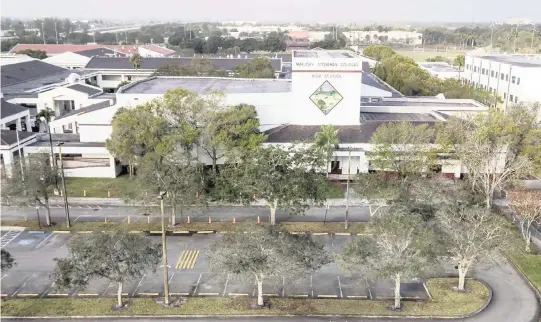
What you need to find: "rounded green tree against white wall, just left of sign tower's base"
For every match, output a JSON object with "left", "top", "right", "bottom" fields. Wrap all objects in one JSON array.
[{"left": 200, "top": 104, "right": 265, "bottom": 172}]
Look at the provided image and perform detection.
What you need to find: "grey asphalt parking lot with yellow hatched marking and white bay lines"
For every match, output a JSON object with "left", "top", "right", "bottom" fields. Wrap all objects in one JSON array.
[{"left": 1, "top": 231, "right": 427, "bottom": 299}]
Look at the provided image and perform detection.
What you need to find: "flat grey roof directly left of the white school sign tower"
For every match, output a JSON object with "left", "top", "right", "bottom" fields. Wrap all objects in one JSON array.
[{"left": 119, "top": 76, "right": 291, "bottom": 94}]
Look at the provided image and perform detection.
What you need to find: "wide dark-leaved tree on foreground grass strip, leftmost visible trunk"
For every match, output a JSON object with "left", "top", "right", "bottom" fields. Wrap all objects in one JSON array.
[{"left": 53, "top": 231, "right": 162, "bottom": 308}]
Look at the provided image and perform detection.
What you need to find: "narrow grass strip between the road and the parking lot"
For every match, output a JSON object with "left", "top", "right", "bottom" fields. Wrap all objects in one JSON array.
[{"left": 1, "top": 220, "right": 366, "bottom": 234}]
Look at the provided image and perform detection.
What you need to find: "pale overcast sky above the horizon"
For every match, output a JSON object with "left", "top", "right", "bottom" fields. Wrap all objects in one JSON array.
[{"left": 0, "top": 0, "right": 541, "bottom": 23}]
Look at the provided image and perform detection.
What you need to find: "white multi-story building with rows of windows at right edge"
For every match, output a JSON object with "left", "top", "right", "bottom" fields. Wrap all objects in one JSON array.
[{"left": 460, "top": 55, "right": 541, "bottom": 108}]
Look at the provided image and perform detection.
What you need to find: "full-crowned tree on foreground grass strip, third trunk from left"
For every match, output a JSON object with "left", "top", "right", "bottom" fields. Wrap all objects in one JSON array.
[{"left": 339, "top": 208, "right": 439, "bottom": 309}]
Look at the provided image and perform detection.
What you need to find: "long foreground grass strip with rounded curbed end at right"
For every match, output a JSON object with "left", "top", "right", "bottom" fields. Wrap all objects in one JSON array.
[{"left": 1, "top": 278, "right": 489, "bottom": 316}]
